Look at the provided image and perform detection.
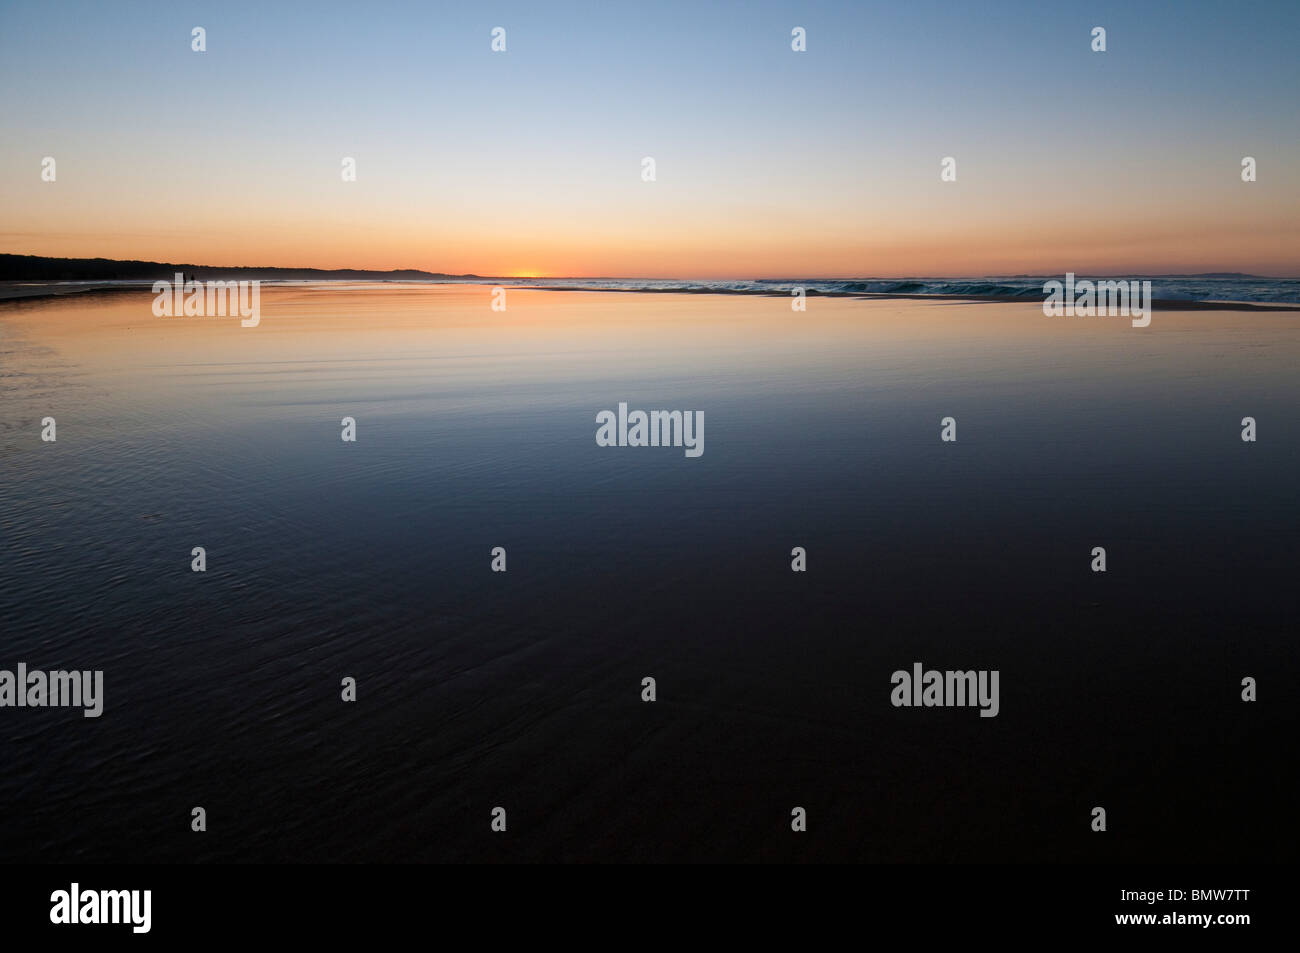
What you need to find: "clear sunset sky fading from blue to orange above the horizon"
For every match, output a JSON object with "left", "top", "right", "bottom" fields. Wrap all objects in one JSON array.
[{"left": 0, "top": 0, "right": 1300, "bottom": 278}]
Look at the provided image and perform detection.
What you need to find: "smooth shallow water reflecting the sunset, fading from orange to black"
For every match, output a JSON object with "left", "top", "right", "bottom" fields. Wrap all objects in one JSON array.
[{"left": 0, "top": 286, "right": 1300, "bottom": 861}]
